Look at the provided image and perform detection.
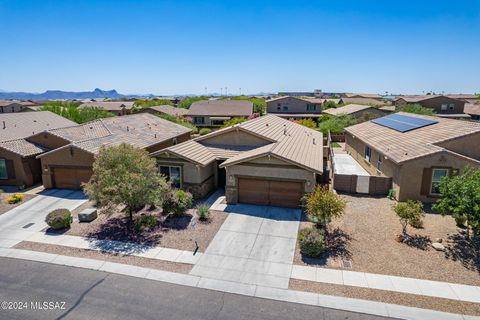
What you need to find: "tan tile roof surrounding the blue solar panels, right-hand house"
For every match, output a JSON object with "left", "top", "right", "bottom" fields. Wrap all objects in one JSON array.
[{"left": 345, "top": 112, "right": 480, "bottom": 163}]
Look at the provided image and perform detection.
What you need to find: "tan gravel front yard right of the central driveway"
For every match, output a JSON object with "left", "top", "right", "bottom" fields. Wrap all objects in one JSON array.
[{"left": 294, "top": 195, "right": 480, "bottom": 285}]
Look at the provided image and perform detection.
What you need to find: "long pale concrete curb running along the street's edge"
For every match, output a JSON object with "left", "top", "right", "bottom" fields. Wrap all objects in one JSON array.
[{"left": 0, "top": 248, "right": 477, "bottom": 320}]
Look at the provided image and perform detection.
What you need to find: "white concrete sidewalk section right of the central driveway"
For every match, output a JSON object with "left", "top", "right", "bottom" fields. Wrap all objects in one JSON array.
[{"left": 292, "top": 266, "right": 480, "bottom": 303}]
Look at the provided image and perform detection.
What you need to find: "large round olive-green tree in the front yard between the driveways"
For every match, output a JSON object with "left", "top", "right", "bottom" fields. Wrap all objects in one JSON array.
[{"left": 84, "top": 143, "right": 170, "bottom": 222}]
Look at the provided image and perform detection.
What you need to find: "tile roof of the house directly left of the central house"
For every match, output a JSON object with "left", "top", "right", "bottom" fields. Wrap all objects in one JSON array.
[{"left": 38, "top": 113, "right": 191, "bottom": 154}]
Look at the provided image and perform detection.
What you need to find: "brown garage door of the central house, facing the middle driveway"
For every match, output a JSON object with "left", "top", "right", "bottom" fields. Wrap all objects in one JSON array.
[{"left": 238, "top": 178, "right": 304, "bottom": 208}]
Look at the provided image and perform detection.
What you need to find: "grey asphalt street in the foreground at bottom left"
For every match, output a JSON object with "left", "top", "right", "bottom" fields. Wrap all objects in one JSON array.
[{"left": 0, "top": 258, "right": 398, "bottom": 320}]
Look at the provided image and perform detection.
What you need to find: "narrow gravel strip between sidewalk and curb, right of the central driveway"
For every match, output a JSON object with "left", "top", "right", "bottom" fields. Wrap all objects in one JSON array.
[{"left": 289, "top": 279, "right": 480, "bottom": 316}]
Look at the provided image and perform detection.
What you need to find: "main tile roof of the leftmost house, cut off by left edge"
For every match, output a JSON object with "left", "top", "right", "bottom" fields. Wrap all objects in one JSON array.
[{"left": 0, "top": 111, "right": 76, "bottom": 141}]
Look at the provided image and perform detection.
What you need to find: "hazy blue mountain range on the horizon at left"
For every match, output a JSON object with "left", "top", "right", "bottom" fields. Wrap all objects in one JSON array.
[{"left": 0, "top": 88, "right": 151, "bottom": 100}]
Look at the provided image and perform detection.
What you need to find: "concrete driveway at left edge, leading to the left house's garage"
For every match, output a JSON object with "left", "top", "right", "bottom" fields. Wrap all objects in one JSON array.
[{"left": 0, "top": 189, "right": 88, "bottom": 248}]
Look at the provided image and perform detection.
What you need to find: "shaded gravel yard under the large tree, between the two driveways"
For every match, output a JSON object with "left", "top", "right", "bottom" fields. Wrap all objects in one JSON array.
[{"left": 65, "top": 204, "right": 227, "bottom": 252}]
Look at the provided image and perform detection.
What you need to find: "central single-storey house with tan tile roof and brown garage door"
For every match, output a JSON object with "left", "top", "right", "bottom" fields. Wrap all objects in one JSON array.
[{"left": 152, "top": 115, "right": 326, "bottom": 207}]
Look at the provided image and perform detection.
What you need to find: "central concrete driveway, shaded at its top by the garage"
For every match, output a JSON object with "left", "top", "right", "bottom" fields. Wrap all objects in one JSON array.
[{"left": 190, "top": 204, "right": 301, "bottom": 288}]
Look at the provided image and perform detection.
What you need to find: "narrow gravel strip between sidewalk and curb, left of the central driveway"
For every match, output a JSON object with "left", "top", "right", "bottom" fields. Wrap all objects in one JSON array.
[{"left": 14, "top": 241, "right": 193, "bottom": 274}]
